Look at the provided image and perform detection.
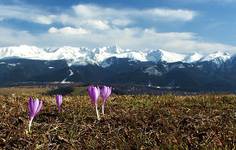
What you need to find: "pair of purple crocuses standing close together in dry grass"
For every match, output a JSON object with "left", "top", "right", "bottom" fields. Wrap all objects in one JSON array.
[{"left": 88, "top": 86, "right": 112, "bottom": 120}]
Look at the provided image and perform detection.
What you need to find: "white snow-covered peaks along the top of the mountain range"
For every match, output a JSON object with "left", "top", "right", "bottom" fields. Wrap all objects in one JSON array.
[{"left": 0, "top": 45, "right": 231, "bottom": 66}]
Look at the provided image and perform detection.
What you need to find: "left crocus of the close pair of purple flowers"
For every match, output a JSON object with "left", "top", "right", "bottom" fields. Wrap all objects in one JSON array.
[{"left": 88, "top": 86, "right": 100, "bottom": 120}]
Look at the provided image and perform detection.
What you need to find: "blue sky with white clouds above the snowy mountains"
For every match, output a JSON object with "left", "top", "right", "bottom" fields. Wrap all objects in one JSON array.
[{"left": 0, "top": 0, "right": 236, "bottom": 53}]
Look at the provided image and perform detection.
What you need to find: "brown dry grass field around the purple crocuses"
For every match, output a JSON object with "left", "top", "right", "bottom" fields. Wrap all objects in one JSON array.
[{"left": 0, "top": 89, "right": 236, "bottom": 150}]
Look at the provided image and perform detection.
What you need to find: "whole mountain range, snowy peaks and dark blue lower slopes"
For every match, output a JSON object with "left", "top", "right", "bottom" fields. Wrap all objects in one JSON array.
[{"left": 0, "top": 45, "right": 236, "bottom": 91}]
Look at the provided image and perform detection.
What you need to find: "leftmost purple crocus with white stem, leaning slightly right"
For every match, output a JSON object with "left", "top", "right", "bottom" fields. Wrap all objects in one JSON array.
[{"left": 28, "top": 97, "right": 43, "bottom": 132}]
